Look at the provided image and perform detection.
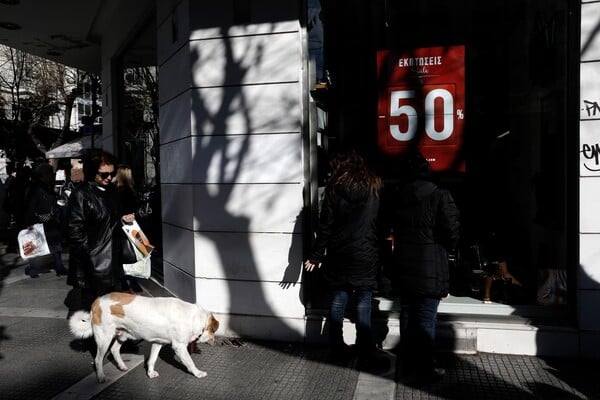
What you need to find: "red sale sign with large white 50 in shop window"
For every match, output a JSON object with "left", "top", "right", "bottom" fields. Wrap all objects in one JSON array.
[{"left": 377, "top": 46, "right": 465, "bottom": 171}]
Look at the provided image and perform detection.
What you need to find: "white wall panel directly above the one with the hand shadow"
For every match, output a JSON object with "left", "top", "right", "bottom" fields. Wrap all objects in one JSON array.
[{"left": 194, "top": 183, "right": 302, "bottom": 232}]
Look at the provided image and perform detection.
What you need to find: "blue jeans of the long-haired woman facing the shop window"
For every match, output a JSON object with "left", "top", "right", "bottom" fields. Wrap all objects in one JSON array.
[{"left": 329, "top": 290, "right": 374, "bottom": 354}]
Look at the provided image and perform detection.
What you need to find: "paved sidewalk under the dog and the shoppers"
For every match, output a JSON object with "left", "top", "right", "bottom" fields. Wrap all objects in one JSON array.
[{"left": 0, "top": 254, "right": 600, "bottom": 400}]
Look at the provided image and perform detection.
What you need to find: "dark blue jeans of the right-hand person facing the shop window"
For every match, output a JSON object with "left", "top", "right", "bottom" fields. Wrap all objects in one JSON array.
[{"left": 400, "top": 295, "right": 440, "bottom": 373}]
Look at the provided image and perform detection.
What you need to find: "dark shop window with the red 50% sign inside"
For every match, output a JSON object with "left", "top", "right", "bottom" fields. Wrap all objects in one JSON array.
[{"left": 307, "top": 0, "right": 579, "bottom": 318}]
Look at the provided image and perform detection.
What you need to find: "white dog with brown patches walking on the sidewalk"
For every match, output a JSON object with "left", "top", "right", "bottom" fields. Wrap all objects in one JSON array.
[{"left": 69, "top": 293, "right": 219, "bottom": 382}]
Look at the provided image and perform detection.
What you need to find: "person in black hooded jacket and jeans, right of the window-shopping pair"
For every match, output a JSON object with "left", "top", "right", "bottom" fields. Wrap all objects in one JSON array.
[{"left": 385, "top": 153, "right": 460, "bottom": 381}]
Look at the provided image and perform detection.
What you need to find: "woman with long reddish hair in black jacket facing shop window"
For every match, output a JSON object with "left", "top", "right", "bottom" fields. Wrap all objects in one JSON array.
[{"left": 304, "top": 152, "right": 381, "bottom": 365}]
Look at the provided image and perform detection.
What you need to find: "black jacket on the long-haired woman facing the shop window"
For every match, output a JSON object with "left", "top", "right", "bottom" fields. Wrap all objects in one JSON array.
[{"left": 309, "top": 186, "right": 379, "bottom": 290}]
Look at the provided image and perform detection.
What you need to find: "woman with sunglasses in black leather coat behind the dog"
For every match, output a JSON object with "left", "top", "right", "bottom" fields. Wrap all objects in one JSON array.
[{"left": 67, "top": 151, "right": 134, "bottom": 309}]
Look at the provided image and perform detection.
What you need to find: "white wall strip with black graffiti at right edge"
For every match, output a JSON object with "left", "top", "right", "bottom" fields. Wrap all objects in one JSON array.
[{"left": 577, "top": 1, "right": 600, "bottom": 357}]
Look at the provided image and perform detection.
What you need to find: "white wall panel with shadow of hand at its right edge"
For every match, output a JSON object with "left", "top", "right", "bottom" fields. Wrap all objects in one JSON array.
[{"left": 195, "top": 232, "right": 302, "bottom": 285}]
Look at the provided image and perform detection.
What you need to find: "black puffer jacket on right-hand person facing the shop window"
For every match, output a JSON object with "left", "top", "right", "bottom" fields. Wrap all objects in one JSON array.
[{"left": 389, "top": 180, "right": 460, "bottom": 298}]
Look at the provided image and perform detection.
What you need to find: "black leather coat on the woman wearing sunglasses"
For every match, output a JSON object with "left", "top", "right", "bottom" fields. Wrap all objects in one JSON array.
[{"left": 67, "top": 182, "right": 123, "bottom": 294}]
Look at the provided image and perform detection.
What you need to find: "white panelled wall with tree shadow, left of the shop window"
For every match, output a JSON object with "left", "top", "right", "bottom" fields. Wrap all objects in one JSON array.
[{"left": 156, "top": 0, "right": 305, "bottom": 339}]
